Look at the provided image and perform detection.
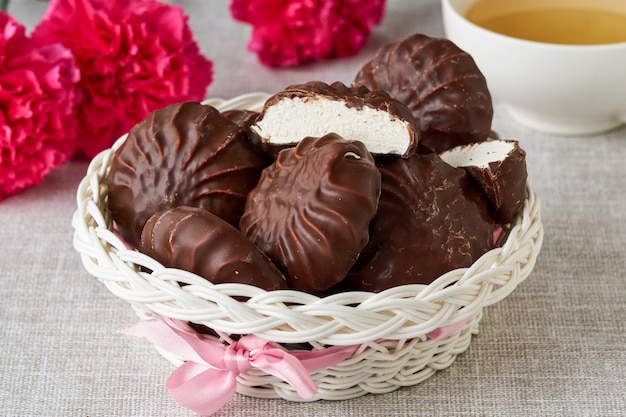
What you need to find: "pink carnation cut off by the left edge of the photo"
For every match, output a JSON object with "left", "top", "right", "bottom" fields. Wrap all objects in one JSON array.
[{"left": 0, "top": 11, "right": 79, "bottom": 201}]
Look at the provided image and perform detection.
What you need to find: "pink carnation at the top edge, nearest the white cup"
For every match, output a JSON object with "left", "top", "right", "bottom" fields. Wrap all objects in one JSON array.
[{"left": 230, "top": 0, "right": 385, "bottom": 67}]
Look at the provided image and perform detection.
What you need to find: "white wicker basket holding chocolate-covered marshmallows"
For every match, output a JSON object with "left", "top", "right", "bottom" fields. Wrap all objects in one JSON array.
[{"left": 73, "top": 93, "right": 543, "bottom": 401}]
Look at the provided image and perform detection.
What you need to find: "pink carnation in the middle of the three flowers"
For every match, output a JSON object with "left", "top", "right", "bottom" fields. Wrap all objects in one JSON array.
[{"left": 33, "top": 0, "right": 213, "bottom": 158}]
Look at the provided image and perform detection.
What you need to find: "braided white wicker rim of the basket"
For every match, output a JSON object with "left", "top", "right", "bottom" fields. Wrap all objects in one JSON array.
[{"left": 72, "top": 93, "right": 543, "bottom": 345}]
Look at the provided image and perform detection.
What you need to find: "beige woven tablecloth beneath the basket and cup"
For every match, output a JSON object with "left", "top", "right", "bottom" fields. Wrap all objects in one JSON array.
[{"left": 0, "top": 0, "right": 626, "bottom": 417}]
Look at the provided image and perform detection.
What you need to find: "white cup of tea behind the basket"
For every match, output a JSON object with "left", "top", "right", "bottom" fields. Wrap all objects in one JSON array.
[{"left": 442, "top": 0, "right": 626, "bottom": 135}]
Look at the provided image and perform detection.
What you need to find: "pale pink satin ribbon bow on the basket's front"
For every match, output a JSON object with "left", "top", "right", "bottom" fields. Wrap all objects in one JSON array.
[{"left": 121, "top": 319, "right": 357, "bottom": 415}]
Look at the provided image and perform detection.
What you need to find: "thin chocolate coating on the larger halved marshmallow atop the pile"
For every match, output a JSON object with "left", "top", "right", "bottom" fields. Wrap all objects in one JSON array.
[{"left": 251, "top": 81, "right": 417, "bottom": 156}]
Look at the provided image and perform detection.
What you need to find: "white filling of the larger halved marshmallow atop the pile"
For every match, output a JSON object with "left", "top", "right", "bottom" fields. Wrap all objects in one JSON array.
[{"left": 252, "top": 97, "right": 414, "bottom": 155}]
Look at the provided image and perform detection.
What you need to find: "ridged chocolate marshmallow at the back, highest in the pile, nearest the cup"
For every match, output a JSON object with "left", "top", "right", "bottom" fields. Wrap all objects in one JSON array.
[{"left": 353, "top": 34, "right": 493, "bottom": 153}]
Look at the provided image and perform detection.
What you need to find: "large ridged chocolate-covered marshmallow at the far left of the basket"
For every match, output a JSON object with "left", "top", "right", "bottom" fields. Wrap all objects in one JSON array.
[{"left": 108, "top": 102, "right": 264, "bottom": 246}]
